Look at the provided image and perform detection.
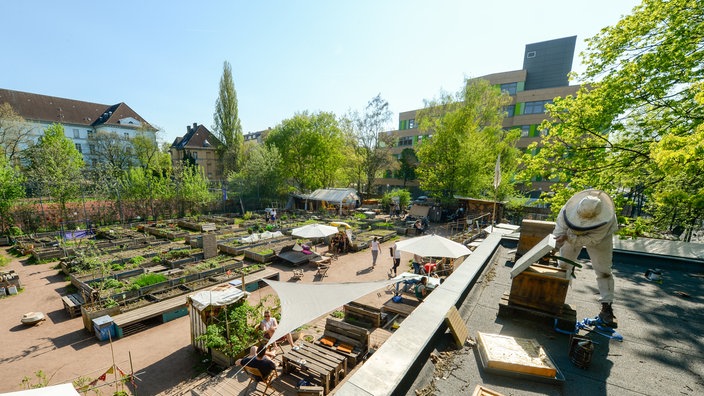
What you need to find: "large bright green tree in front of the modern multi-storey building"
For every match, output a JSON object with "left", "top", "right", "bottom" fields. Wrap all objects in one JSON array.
[{"left": 416, "top": 79, "right": 518, "bottom": 201}]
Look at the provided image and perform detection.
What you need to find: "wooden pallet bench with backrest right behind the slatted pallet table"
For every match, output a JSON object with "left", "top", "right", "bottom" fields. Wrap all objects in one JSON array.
[{"left": 315, "top": 318, "right": 369, "bottom": 369}]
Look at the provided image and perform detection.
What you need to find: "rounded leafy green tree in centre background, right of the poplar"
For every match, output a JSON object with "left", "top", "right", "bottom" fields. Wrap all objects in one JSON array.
[{"left": 265, "top": 112, "right": 345, "bottom": 192}]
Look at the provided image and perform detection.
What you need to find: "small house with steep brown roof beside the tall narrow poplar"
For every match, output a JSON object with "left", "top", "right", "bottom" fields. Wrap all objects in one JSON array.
[{"left": 169, "top": 122, "right": 223, "bottom": 181}]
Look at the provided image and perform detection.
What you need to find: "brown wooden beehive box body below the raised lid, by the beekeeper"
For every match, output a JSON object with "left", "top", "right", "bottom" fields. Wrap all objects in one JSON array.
[{"left": 509, "top": 264, "right": 570, "bottom": 314}]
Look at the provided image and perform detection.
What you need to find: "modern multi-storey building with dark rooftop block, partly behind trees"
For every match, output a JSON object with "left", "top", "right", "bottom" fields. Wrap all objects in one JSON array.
[{"left": 376, "top": 36, "right": 580, "bottom": 195}]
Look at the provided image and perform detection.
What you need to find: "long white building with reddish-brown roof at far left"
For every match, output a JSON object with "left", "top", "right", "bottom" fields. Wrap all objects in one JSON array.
[{"left": 0, "top": 89, "right": 157, "bottom": 169}]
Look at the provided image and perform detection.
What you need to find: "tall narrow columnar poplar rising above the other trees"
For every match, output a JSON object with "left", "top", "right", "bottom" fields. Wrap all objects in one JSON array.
[{"left": 213, "top": 61, "right": 244, "bottom": 176}]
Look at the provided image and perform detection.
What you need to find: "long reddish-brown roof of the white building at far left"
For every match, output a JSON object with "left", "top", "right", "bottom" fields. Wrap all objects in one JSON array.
[{"left": 0, "top": 89, "right": 155, "bottom": 130}]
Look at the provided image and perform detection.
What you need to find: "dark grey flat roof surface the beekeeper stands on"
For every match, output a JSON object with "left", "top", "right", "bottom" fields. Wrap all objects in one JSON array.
[{"left": 408, "top": 237, "right": 704, "bottom": 396}]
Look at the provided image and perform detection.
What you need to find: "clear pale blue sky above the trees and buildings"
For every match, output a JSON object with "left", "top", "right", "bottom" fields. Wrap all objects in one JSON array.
[{"left": 0, "top": 0, "right": 640, "bottom": 142}]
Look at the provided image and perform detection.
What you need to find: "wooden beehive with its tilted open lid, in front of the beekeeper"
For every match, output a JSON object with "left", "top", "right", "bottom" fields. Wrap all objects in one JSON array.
[{"left": 508, "top": 235, "right": 570, "bottom": 314}]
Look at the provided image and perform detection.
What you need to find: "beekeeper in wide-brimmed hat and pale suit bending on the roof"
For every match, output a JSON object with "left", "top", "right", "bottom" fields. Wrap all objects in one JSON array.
[{"left": 553, "top": 189, "right": 618, "bottom": 328}]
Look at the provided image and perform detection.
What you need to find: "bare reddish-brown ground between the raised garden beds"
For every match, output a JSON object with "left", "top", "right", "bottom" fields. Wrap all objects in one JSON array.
[{"left": 0, "top": 221, "right": 426, "bottom": 395}]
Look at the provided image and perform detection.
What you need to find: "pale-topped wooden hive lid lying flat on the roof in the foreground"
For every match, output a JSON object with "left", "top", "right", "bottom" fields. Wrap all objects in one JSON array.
[{"left": 477, "top": 332, "right": 557, "bottom": 378}]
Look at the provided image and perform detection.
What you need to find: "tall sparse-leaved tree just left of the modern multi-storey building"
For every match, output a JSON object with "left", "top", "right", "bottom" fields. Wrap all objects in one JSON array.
[{"left": 350, "top": 94, "right": 396, "bottom": 193}]
